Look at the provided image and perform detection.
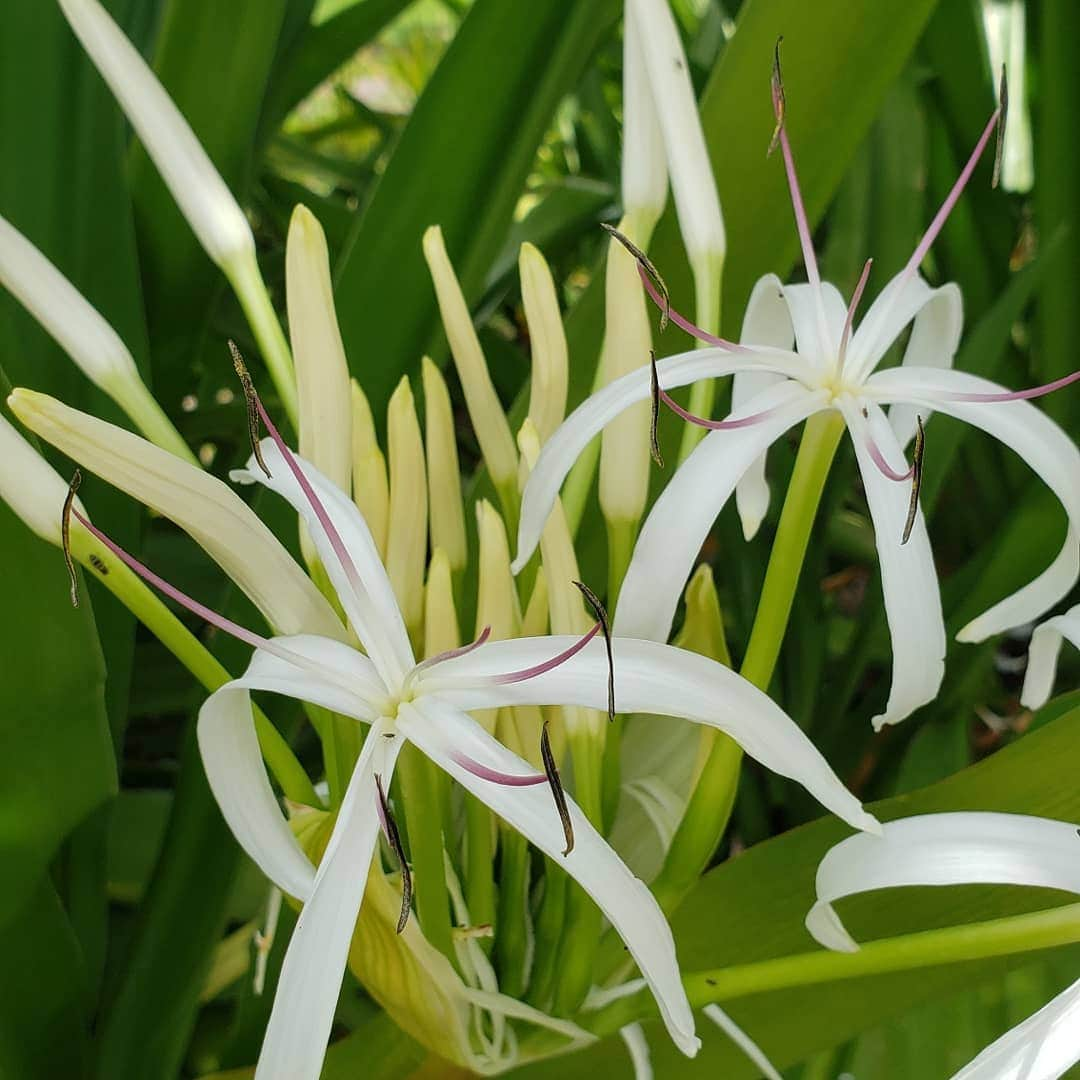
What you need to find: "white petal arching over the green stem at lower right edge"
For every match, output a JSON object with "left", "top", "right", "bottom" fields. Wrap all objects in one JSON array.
[{"left": 806, "top": 812, "right": 1080, "bottom": 953}]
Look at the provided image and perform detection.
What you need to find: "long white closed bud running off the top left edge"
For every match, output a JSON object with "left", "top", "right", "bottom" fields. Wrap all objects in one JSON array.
[{"left": 59, "top": 0, "right": 255, "bottom": 265}]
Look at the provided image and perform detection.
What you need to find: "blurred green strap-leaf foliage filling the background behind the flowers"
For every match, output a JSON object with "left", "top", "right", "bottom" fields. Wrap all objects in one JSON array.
[{"left": 0, "top": 0, "right": 1080, "bottom": 1080}]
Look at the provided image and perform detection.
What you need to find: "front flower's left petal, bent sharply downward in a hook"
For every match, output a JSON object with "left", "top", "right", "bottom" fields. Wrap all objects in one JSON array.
[{"left": 198, "top": 635, "right": 382, "bottom": 900}]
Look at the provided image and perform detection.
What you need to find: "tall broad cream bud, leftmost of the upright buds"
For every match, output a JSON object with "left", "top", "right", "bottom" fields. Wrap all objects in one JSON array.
[{"left": 285, "top": 206, "right": 352, "bottom": 495}]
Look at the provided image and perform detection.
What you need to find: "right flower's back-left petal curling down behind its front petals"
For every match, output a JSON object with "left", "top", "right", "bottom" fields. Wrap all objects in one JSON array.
[{"left": 731, "top": 273, "right": 795, "bottom": 540}]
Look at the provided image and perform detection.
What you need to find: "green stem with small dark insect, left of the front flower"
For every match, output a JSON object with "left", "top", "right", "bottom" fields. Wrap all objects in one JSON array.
[{"left": 71, "top": 528, "right": 322, "bottom": 807}]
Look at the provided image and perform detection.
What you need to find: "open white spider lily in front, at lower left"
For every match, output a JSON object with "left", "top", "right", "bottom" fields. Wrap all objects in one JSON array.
[{"left": 67, "top": 384, "right": 879, "bottom": 1080}]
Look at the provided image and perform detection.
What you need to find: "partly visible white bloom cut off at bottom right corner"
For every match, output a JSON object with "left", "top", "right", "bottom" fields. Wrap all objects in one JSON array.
[{"left": 806, "top": 812, "right": 1080, "bottom": 1080}]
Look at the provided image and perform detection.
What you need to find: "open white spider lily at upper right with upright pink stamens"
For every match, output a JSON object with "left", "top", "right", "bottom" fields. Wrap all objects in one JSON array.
[{"left": 514, "top": 69, "right": 1080, "bottom": 728}]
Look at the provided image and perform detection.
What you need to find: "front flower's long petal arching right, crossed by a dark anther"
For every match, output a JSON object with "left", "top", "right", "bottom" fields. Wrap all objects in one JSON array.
[{"left": 412, "top": 635, "right": 877, "bottom": 829}]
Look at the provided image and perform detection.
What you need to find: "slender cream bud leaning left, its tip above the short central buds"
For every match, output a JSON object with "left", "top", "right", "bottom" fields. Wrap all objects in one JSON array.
[{"left": 423, "top": 225, "right": 517, "bottom": 501}]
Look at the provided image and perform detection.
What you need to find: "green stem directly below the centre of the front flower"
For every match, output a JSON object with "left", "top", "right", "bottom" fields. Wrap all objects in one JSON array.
[{"left": 397, "top": 746, "right": 455, "bottom": 966}]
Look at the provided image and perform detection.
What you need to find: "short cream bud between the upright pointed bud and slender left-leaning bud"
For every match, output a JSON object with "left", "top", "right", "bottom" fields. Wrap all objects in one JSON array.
[{"left": 421, "top": 356, "right": 469, "bottom": 573}]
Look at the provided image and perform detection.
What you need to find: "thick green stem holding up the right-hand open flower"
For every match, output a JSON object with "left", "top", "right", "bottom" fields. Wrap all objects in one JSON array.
[{"left": 652, "top": 411, "right": 843, "bottom": 912}]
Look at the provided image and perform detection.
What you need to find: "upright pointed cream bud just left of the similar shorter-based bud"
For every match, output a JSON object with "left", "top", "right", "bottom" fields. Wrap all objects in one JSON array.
[{"left": 387, "top": 376, "right": 428, "bottom": 642}]
